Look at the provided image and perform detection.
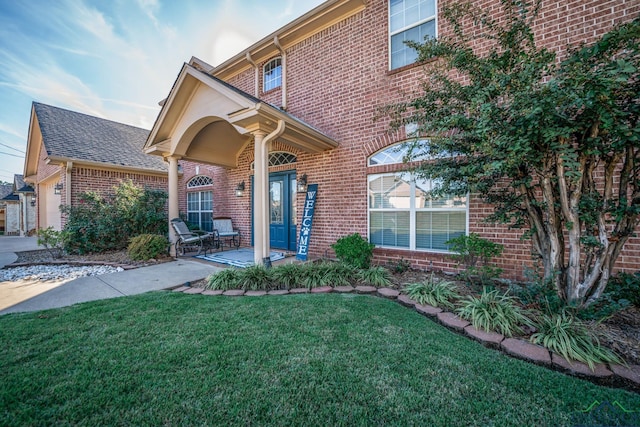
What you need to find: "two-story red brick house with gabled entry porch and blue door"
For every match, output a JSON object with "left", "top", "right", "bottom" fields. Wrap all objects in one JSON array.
[{"left": 145, "top": 0, "right": 640, "bottom": 277}]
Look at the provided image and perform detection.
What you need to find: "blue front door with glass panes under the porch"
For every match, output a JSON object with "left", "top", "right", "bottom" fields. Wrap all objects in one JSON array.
[{"left": 251, "top": 171, "right": 297, "bottom": 251}]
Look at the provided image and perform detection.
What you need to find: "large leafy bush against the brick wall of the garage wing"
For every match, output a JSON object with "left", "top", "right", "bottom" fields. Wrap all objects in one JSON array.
[{"left": 60, "top": 181, "right": 167, "bottom": 254}]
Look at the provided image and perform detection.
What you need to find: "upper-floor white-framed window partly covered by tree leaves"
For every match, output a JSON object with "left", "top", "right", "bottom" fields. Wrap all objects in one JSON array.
[{"left": 389, "top": 0, "right": 437, "bottom": 70}]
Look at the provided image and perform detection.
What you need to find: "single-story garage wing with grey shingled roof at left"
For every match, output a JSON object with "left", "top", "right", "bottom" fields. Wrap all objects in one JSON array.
[{"left": 24, "top": 102, "right": 167, "bottom": 230}]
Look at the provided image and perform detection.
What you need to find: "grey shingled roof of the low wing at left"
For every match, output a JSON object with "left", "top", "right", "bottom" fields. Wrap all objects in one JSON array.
[{"left": 33, "top": 102, "right": 167, "bottom": 172}]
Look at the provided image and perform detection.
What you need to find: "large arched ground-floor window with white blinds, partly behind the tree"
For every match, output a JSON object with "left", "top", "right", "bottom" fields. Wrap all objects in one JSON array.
[{"left": 367, "top": 143, "right": 468, "bottom": 252}]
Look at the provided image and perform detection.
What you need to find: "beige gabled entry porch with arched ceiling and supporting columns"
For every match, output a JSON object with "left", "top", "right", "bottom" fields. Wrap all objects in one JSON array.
[{"left": 145, "top": 64, "right": 338, "bottom": 264}]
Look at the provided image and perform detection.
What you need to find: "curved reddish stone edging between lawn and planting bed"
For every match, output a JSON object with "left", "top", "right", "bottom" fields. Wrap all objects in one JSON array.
[{"left": 169, "top": 284, "right": 640, "bottom": 393}]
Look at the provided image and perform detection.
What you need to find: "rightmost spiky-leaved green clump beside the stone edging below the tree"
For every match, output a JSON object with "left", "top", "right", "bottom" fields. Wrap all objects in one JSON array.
[{"left": 531, "top": 310, "right": 623, "bottom": 370}]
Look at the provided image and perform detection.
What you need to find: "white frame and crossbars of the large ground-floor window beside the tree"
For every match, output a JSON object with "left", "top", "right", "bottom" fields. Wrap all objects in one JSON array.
[{"left": 367, "top": 171, "right": 470, "bottom": 254}]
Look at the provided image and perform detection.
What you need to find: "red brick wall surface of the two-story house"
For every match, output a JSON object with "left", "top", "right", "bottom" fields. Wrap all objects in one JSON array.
[{"left": 201, "top": 0, "right": 640, "bottom": 277}]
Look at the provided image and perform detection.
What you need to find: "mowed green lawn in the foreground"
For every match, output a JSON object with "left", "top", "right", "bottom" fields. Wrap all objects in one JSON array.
[{"left": 0, "top": 292, "right": 640, "bottom": 426}]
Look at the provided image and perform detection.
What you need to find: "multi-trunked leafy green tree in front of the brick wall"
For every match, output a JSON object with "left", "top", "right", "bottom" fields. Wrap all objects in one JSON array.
[{"left": 384, "top": 0, "right": 640, "bottom": 307}]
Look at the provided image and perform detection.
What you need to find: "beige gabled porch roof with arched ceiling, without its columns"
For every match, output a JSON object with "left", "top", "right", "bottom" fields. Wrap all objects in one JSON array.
[{"left": 144, "top": 64, "right": 338, "bottom": 168}]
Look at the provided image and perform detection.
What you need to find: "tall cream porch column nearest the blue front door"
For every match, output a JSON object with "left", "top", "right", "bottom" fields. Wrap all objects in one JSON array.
[{"left": 253, "top": 131, "right": 269, "bottom": 265}]
